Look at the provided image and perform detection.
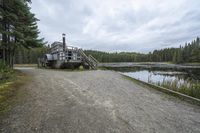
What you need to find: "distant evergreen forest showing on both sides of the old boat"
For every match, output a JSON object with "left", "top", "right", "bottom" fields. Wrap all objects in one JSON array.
[{"left": 14, "top": 37, "right": 200, "bottom": 64}]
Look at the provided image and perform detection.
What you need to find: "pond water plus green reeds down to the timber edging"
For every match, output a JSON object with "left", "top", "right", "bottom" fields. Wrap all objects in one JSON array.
[{"left": 104, "top": 67, "right": 200, "bottom": 98}]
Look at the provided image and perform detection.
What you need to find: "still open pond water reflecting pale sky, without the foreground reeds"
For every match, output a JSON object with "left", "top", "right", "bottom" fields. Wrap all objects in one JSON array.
[{"left": 107, "top": 67, "right": 200, "bottom": 82}]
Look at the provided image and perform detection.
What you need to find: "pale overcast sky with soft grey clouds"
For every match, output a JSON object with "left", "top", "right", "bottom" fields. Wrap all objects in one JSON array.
[{"left": 31, "top": 0, "right": 200, "bottom": 52}]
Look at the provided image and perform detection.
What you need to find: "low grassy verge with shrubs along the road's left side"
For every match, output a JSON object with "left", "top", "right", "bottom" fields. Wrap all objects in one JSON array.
[{"left": 0, "top": 62, "right": 28, "bottom": 116}]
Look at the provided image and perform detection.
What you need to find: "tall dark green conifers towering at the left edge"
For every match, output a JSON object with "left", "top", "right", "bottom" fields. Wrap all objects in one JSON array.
[{"left": 0, "top": 0, "right": 44, "bottom": 67}]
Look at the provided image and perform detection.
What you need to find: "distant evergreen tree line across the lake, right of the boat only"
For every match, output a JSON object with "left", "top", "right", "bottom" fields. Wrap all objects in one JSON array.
[{"left": 85, "top": 37, "right": 200, "bottom": 63}]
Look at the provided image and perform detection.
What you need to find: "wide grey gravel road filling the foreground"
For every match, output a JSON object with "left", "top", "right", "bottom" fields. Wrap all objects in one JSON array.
[{"left": 0, "top": 68, "right": 200, "bottom": 133}]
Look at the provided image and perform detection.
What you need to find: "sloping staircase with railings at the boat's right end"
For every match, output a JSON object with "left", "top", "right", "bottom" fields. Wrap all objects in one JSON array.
[{"left": 78, "top": 49, "right": 99, "bottom": 69}]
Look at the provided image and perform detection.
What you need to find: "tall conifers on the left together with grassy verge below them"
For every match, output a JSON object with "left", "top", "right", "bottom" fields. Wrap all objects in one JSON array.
[{"left": 0, "top": 0, "right": 43, "bottom": 112}]
